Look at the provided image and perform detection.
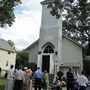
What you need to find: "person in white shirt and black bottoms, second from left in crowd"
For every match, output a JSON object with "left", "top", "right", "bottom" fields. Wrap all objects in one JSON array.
[{"left": 13, "top": 66, "right": 25, "bottom": 90}]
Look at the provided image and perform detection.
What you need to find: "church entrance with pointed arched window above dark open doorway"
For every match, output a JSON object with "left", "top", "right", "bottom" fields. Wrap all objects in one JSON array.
[{"left": 41, "top": 42, "right": 54, "bottom": 73}]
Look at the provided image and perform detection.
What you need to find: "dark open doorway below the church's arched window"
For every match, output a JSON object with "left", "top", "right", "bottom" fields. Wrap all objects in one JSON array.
[{"left": 42, "top": 55, "right": 50, "bottom": 73}]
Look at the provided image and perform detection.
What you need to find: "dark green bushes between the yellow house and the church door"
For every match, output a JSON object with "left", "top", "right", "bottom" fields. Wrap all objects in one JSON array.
[{"left": 15, "top": 50, "right": 37, "bottom": 71}]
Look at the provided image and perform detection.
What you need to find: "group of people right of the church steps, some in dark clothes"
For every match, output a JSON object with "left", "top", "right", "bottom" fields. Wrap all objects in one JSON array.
[{"left": 54, "top": 67, "right": 88, "bottom": 90}]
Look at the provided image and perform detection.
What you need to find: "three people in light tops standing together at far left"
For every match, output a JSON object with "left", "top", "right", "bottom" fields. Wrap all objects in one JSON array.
[{"left": 5, "top": 65, "right": 32, "bottom": 90}]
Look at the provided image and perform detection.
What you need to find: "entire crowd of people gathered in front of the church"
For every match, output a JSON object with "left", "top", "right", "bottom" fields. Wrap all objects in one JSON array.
[{"left": 5, "top": 65, "right": 88, "bottom": 90}]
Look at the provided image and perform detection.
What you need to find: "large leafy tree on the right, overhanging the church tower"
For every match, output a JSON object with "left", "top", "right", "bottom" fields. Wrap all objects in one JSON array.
[{"left": 47, "top": 0, "right": 90, "bottom": 54}]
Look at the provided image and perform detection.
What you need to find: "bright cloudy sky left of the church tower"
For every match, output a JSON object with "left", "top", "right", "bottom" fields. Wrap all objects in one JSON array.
[{"left": 0, "top": 0, "right": 43, "bottom": 50}]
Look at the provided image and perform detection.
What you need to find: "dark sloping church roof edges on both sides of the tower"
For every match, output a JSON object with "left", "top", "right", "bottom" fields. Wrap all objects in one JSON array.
[{"left": 26, "top": 34, "right": 84, "bottom": 50}]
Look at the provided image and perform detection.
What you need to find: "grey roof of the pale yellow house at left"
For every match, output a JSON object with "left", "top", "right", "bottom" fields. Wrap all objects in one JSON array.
[{"left": 0, "top": 39, "right": 15, "bottom": 52}]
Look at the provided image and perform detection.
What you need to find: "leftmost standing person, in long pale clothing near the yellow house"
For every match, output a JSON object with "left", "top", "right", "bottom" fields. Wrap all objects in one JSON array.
[{"left": 5, "top": 65, "right": 14, "bottom": 90}]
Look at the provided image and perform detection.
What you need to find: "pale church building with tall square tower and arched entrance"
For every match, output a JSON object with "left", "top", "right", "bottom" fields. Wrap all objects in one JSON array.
[{"left": 27, "top": 0, "right": 83, "bottom": 73}]
